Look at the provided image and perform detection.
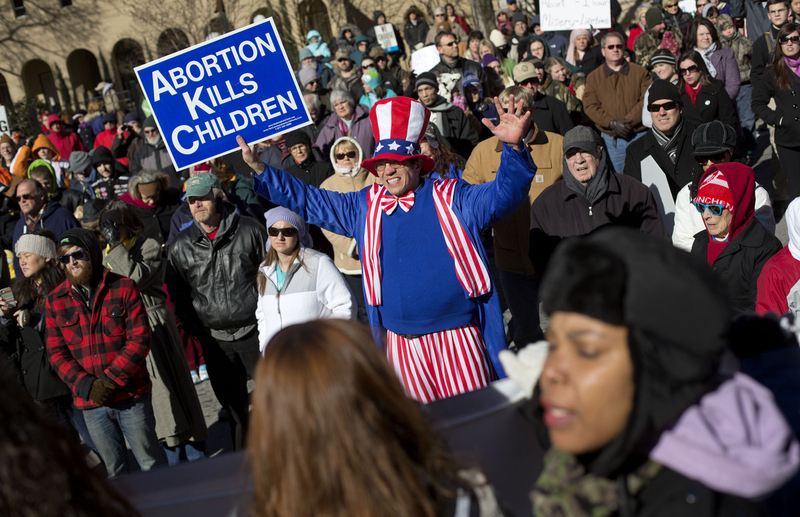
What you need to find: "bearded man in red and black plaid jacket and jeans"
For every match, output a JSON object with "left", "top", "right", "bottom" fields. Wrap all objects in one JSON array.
[{"left": 45, "top": 228, "right": 166, "bottom": 477}]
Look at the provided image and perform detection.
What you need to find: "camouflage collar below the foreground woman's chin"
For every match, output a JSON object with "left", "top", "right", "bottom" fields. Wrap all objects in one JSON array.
[{"left": 531, "top": 448, "right": 663, "bottom": 517}]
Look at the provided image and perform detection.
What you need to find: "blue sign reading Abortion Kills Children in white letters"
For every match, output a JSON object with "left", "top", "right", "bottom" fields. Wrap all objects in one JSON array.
[{"left": 136, "top": 18, "right": 311, "bottom": 170}]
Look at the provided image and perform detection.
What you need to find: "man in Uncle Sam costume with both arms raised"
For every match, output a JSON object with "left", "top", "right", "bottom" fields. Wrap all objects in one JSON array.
[{"left": 238, "top": 97, "right": 536, "bottom": 403}]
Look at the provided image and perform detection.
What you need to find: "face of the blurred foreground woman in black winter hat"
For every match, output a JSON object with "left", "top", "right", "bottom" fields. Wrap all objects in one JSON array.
[{"left": 539, "top": 312, "right": 635, "bottom": 455}]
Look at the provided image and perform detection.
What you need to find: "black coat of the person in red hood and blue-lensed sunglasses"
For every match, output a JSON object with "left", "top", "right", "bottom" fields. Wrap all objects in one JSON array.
[{"left": 692, "top": 217, "right": 782, "bottom": 312}]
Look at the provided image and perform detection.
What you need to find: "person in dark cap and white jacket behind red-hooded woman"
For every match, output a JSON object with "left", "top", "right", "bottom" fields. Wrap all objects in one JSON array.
[{"left": 672, "top": 120, "right": 775, "bottom": 251}]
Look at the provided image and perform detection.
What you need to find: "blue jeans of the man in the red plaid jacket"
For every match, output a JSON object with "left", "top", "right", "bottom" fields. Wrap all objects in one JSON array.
[{"left": 83, "top": 393, "right": 167, "bottom": 478}]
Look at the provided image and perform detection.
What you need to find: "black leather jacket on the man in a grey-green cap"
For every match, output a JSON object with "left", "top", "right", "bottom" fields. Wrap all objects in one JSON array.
[{"left": 166, "top": 201, "right": 267, "bottom": 331}]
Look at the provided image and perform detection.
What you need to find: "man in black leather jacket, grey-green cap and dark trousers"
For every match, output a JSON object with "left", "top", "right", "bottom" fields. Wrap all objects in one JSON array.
[{"left": 166, "top": 173, "right": 267, "bottom": 450}]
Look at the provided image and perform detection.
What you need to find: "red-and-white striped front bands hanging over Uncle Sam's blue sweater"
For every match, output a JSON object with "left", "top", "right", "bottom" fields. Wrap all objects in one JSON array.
[{"left": 361, "top": 179, "right": 492, "bottom": 306}]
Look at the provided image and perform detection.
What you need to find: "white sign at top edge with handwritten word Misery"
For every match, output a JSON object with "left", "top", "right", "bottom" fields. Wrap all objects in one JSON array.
[{"left": 539, "top": 0, "right": 611, "bottom": 32}]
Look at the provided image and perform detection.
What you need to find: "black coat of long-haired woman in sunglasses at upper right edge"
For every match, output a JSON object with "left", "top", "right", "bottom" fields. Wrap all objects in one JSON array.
[{"left": 752, "top": 67, "right": 800, "bottom": 147}]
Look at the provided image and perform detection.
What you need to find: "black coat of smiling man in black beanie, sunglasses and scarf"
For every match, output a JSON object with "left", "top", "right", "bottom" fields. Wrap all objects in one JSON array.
[{"left": 622, "top": 120, "right": 700, "bottom": 199}]
